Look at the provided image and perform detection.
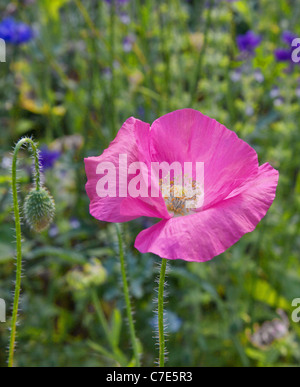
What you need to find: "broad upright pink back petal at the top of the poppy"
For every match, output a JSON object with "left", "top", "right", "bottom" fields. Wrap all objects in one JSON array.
[{"left": 150, "top": 109, "right": 258, "bottom": 208}]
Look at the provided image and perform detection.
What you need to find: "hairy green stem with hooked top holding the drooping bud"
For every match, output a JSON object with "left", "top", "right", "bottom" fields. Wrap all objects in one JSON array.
[{"left": 8, "top": 138, "right": 41, "bottom": 367}]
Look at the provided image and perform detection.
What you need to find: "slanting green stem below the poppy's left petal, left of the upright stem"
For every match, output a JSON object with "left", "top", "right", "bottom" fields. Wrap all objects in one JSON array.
[{"left": 116, "top": 225, "right": 141, "bottom": 367}]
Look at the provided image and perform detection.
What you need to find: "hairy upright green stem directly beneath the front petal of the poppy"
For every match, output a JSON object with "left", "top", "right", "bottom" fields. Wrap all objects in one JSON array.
[{"left": 158, "top": 259, "right": 167, "bottom": 367}]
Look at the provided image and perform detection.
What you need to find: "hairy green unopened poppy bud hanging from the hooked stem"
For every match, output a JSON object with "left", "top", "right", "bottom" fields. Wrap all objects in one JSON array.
[{"left": 24, "top": 188, "right": 55, "bottom": 232}]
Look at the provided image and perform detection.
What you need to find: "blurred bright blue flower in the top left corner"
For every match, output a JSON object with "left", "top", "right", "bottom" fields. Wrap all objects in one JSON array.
[{"left": 0, "top": 18, "right": 34, "bottom": 45}]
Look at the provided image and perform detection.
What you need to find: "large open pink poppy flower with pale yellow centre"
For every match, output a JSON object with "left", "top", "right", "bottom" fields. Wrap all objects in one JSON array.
[{"left": 85, "top": 109, "right": 279, "bottom": 262}]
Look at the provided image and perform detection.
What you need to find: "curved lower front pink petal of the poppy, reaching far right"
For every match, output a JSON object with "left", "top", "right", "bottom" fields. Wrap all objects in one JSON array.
[{"left": 135, "top": 164, "right": 279, "bottom": 262}]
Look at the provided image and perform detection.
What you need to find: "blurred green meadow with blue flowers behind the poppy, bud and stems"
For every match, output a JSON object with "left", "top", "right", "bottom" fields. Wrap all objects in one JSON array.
[{"left": 0, "top": 0, "right": 300, "bottom": 367}]
